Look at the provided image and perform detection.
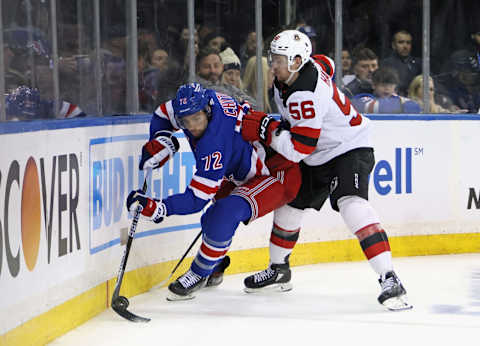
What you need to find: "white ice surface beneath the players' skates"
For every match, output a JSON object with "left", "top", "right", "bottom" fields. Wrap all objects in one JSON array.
[{"left": 51, "top": 254, "right": 480, "bottom": 346}]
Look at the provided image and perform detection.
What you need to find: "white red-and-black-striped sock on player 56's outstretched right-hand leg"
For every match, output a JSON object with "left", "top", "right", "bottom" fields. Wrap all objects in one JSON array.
[{"left": 338, "top": 196, "right": 393, "bottom": 275}]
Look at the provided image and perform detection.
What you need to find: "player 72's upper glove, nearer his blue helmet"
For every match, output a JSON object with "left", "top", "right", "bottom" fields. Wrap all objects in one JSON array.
[{"left": 139, "top": 131, "right": 180, "bottom": 170}]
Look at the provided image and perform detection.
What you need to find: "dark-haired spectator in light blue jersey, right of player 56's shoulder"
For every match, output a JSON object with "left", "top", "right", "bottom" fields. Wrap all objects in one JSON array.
[{"left": 352, "top": 67, "right": 421, "bottom": 114}]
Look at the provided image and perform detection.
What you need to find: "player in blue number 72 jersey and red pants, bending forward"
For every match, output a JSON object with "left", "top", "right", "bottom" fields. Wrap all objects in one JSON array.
[{"left": 127, "top": 83, "right": 300, "bottom": 300}]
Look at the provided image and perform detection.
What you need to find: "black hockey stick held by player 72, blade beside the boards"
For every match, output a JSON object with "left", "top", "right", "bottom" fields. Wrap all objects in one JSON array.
[{"left": 111, "top": 169, "right": 152, "bottom": 322}]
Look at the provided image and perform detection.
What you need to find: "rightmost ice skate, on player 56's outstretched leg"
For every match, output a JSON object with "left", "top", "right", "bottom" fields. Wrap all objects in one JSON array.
[{"left": 378, "top": 271, "right": 413, "bottom": 311}]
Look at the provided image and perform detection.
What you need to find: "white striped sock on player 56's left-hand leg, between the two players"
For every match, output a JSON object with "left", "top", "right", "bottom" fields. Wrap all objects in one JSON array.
[{"left": 270, "top": 205, "right": 304, "bottom": 263}]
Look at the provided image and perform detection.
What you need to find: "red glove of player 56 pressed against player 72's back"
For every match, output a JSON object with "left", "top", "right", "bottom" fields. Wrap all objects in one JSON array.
[{"left": 242, "top": 111, "right": 280, "bottom": 145}]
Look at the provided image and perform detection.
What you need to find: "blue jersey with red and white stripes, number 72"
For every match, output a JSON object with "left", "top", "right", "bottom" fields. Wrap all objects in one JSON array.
[{"left": 150, "top": 90, "right": 269, "bottom": 215}]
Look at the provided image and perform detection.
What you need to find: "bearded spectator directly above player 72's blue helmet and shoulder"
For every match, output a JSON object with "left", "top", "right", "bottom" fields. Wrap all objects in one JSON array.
[{"left": 197, "top": 48, "right": 256, "bottom": 107}]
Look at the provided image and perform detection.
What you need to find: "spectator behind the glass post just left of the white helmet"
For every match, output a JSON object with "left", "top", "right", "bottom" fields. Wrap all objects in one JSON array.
[{"left": 243, "top": 56, "right": 278, "bottom": 113}]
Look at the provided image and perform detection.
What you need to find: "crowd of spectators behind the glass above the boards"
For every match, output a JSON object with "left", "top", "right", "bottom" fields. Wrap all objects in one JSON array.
[{"left": 1, "top": 0, "right": 480, "bottom": 121}]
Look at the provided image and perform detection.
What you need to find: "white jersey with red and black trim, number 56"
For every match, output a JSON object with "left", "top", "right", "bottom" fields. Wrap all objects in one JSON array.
[{"left": 271, "top": 60, "right": 371, "bottom": 166}]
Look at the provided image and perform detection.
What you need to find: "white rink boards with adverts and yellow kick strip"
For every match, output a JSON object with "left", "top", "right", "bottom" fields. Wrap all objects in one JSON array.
[{"left": 0, "top": 116, "right": 480, "bottom": 345}]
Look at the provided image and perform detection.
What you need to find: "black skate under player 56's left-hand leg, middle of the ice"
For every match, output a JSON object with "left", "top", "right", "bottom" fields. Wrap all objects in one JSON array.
[{"left": 243, "top": 262, "right": 293, "bottom": 293}]
